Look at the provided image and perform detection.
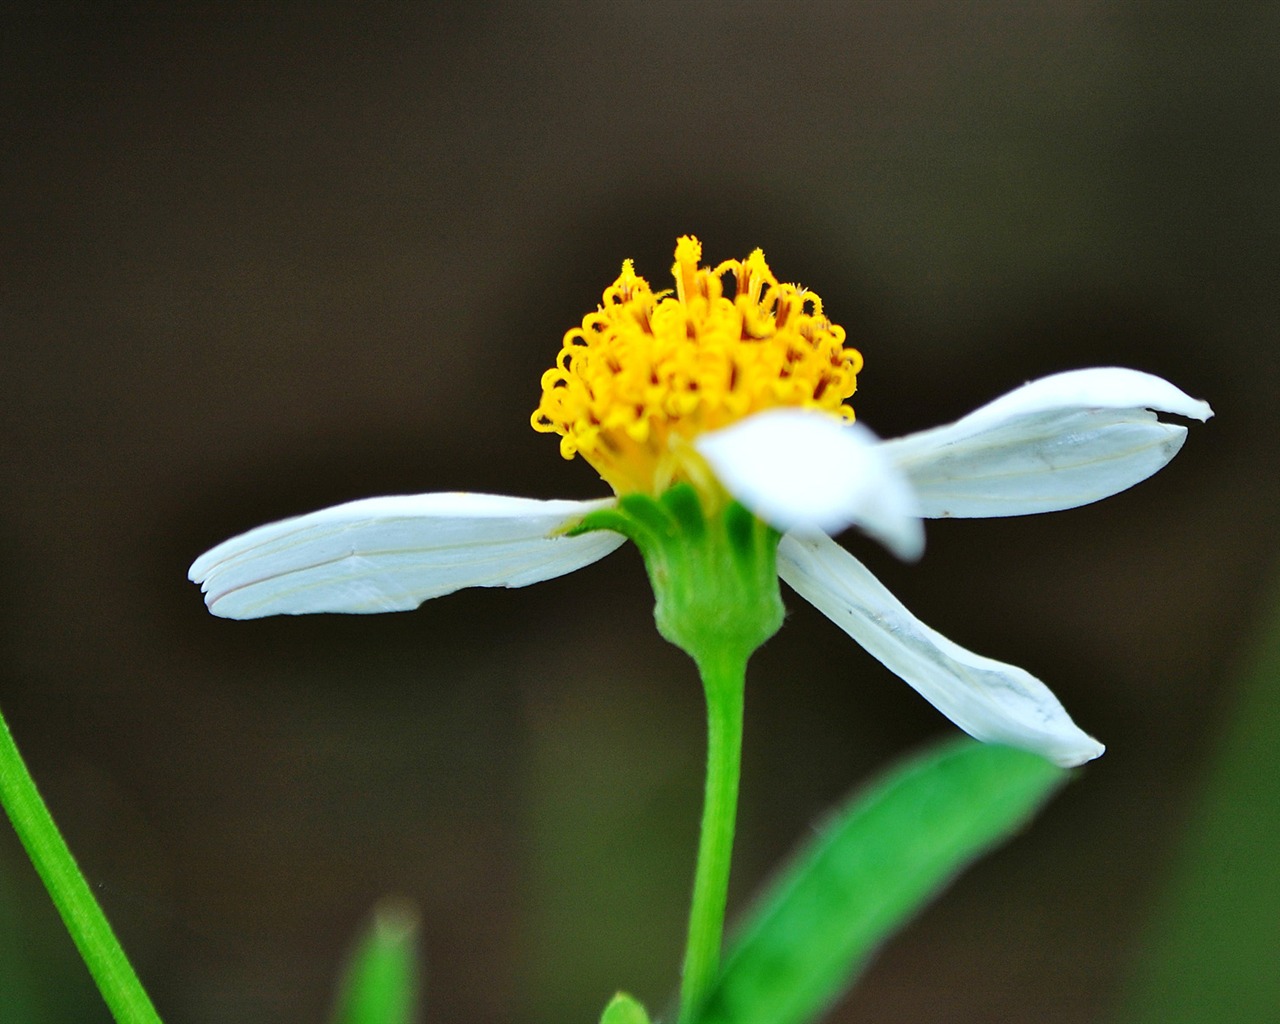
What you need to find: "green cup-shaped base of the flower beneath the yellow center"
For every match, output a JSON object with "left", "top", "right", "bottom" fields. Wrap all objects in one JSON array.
[{"left": 572, "top": 484, "right": 783, "bottom": 675}]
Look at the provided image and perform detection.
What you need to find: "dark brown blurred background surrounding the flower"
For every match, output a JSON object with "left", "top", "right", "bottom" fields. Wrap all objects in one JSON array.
[{"left": 0, "top": 0, "right": 1280, "bottom": 1024}]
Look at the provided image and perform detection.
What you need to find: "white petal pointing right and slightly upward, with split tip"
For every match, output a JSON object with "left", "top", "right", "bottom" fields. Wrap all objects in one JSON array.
[{"left": 884, "top": 367, "right": 1213, "bottom": 518}]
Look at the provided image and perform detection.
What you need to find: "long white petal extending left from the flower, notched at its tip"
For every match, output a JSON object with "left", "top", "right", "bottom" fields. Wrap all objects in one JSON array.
[{"left": 189, "top": 493, "right": 623, "bottom": 618}]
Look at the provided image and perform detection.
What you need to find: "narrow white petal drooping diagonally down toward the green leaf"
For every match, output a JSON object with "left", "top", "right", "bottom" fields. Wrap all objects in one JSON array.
[{"left": 778, "top": 536, "right": 1103, "bottom": 765}]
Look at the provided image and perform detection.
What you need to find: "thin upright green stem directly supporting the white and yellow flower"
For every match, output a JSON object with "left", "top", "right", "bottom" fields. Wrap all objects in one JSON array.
[{"left": 680, "top": 653, "right": 746, "bottom": 1021}]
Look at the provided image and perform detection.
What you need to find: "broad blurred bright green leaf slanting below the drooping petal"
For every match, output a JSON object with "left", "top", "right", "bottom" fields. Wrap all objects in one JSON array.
[{"left": 682, "top": 739, "right": 1066, "bottom": 1024}]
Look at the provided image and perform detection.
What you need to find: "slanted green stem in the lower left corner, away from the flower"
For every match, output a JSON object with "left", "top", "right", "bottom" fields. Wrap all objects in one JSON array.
[{"left": 0, "top": 714, "right": 160, "bottom": 1024}]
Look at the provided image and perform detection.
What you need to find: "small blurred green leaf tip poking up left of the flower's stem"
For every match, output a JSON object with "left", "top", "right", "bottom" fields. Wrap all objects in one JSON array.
[{"left": 332, "top": 901, "right": 419, "bottom": 1024}]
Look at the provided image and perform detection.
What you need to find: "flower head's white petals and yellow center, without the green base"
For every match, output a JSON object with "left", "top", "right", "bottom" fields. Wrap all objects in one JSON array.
[{"left": 189, "top": 237, "right": 1212, "bottom": 765}]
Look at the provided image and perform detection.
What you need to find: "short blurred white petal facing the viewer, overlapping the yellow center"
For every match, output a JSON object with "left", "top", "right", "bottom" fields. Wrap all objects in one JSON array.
[{"left": 695, "top": 408, "right": 924, "bottom": 558}]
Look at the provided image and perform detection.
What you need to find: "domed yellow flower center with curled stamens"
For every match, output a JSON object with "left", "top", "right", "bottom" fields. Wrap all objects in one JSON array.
[{"left": 532, "top": 236, "right": 863, "bottom": 494}]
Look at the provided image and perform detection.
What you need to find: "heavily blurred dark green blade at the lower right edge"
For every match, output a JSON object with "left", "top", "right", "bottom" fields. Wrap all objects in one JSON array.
[{"left": 1120, "top": 581, "right": 1280, "bottom": 1024}]
